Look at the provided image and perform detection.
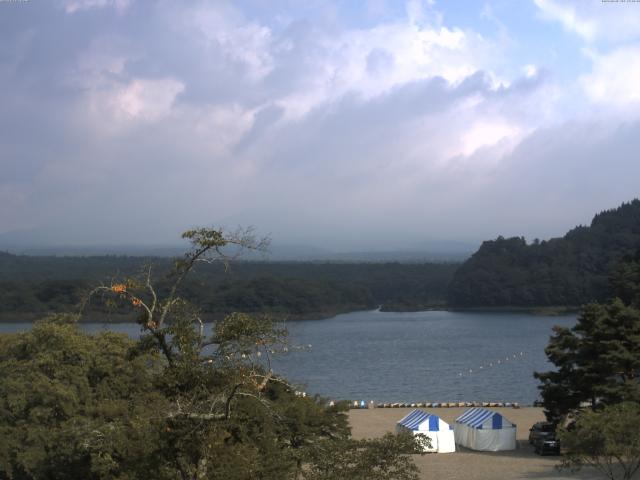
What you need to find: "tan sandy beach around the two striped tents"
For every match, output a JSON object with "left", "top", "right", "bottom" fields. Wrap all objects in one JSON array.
[{"left": 349, "top": 407, "right": 603, "bottom": 480}]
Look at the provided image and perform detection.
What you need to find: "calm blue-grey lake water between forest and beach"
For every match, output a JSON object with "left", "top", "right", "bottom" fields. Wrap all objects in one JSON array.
[{"left": 0, "top": 311, "right": 576, "bottom": 405}]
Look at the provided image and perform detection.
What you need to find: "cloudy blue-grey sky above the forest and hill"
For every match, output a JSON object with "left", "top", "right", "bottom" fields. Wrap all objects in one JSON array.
[{"left": 0, "top": 0, "right": 640, "bottom": 250}]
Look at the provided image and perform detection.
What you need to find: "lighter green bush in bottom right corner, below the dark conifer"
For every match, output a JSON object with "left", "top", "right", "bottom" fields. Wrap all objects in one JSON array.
[{"left": 559, "top": 402, "right": 640, "bottom": 480}]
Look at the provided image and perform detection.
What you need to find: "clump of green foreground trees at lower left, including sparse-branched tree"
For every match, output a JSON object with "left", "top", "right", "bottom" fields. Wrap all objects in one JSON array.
[{"left": 0, "top": 229, "right": 422, "bottom": 480}]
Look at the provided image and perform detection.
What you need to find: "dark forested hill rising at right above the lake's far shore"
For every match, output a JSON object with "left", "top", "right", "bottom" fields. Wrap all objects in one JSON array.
[{"left": 448, "top": 199, "right": 640, "bottom": 307}]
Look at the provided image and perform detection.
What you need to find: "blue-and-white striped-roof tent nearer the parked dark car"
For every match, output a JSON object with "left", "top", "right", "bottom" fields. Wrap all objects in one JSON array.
[{"left": 454, "top": 408, "right": 516, "bottom": 452}]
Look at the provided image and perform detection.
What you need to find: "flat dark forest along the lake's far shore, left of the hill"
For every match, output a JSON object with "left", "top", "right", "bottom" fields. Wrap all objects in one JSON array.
[{"left": 0, "top": 253, "right": 458, "bottom": 320}]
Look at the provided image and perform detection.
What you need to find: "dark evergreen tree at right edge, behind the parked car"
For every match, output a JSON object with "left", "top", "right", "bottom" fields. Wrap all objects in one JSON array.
[{"left": 535, "top": 251, "right": 640, "bottom": 423}]
